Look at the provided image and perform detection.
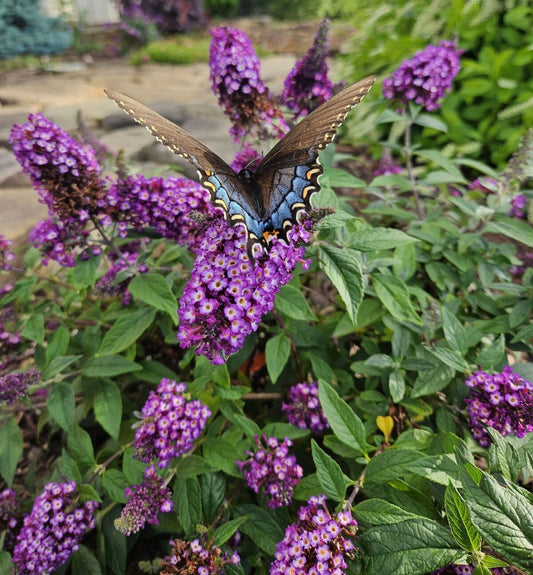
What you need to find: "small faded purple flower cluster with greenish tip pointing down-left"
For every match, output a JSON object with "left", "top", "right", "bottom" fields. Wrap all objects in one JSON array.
[{"left": 115, "top": 465, "right": 172, "bottom": 536}]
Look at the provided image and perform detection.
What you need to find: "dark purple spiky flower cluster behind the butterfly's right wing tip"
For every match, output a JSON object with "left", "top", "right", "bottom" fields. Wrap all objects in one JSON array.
[{"left": 281, "top": 19, "right": 343, "bottom": 119}]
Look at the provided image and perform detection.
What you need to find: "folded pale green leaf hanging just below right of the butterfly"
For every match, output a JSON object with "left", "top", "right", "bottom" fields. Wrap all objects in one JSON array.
[{"left": 318, "top": 245, "right": 363, "bottom": 325}]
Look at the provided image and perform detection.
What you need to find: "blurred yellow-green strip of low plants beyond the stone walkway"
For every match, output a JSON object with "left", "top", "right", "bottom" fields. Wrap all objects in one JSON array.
[{"left": 130, "top": 34, "right": 211, "bottom": 65}]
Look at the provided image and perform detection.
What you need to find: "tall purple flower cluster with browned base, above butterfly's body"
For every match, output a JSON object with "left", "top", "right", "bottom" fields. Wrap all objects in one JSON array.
[{"left": 209, "top": 27, "right": 288, "bottom": 142}]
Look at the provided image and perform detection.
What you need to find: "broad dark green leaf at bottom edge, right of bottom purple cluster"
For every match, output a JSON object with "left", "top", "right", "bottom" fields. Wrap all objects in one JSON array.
[{"left": 359, "top": 517, "right": 464, "bottom": 575}]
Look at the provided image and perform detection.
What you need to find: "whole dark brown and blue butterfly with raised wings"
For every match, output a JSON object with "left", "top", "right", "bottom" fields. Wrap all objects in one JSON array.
[{"left": 104, "top": 76, "right": 376, "bottom": 253}]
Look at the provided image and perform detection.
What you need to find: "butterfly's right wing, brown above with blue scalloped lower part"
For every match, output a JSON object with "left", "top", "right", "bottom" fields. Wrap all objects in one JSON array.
[{"left": 255, "top": 76, "right": 376, "bottom": 238}]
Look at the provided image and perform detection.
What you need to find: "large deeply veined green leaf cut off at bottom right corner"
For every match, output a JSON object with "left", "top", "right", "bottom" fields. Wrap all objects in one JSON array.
[{"left": 459, "top": 462, "right": 533, "bottom": 572}]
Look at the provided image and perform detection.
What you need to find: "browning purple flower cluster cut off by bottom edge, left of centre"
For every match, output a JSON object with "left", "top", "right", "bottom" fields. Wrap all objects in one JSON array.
[{"left": 161, "top": 533, "right": 241, "bottom": 575}]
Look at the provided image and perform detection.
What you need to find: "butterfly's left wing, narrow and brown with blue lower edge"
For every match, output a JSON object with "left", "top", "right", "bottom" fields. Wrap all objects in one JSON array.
[{"left": 104, "top": 90, "right": 262, "bottom": 237}]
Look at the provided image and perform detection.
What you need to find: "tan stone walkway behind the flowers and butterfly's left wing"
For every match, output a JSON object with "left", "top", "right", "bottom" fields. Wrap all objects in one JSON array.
[{"left": 0, "top": 55, "right": 295, "bottom": 241}]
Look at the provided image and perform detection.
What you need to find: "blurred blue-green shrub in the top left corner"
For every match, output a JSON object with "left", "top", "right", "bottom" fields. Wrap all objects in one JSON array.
[{"left": 0, "top": 0, "right": 72, "bottom": 59}]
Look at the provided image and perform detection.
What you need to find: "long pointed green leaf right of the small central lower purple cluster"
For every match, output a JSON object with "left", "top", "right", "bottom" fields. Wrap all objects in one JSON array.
[{"left": 318, "top": 380, "right": 370, "bottom": 457}]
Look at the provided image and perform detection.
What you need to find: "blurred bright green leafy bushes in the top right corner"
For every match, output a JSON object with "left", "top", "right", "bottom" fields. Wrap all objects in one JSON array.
[{"left": 347, "top": 0, "right": 533, "bottom": 167}]
